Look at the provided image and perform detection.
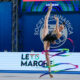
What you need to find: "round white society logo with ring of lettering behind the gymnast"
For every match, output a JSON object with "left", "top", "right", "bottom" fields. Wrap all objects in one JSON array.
[{"left": 34, "top": 15, "right": 73, "bottom": 48}]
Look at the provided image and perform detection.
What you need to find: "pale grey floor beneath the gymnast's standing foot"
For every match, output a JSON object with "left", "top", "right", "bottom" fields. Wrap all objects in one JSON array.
[{"left": 0, "top": 73, "right": 80, "bottom": 80}]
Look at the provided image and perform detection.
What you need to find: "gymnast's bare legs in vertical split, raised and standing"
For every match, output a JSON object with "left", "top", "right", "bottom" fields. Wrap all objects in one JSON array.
[{"left": 42, "top": 4, "right": 53, "bottom": 78}]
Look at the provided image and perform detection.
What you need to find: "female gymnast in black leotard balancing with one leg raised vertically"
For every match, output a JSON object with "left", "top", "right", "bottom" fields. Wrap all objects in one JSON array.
[{"left": 42, "top": 4, "right": 65, "bottom": 78}]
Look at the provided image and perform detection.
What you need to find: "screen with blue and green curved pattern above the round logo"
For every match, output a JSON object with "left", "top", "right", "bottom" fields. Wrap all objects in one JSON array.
[{"left": 22, "top": 0, "right": 80, "bottom": 13}]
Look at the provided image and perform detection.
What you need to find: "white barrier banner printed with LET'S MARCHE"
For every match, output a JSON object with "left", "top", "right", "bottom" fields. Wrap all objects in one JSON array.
[{"left": 0, "top": 52, "right": 80, "bottom": 71}]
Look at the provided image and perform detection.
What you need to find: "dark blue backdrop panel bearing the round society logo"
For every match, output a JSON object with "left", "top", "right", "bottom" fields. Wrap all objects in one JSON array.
[{"left": 21, "top": 12, "right": 80, "bottom": 52}]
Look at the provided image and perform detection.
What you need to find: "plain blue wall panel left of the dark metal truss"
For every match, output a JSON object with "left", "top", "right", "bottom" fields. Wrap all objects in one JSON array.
[{"left": 0, "top": 2, "right": 12, "bottom": 51}]
